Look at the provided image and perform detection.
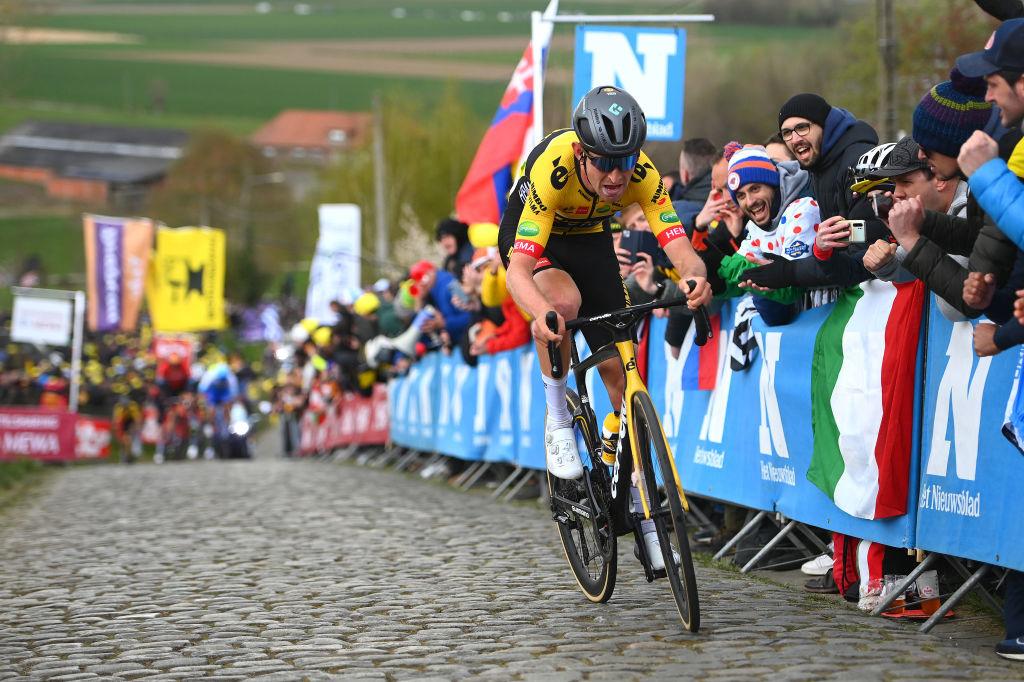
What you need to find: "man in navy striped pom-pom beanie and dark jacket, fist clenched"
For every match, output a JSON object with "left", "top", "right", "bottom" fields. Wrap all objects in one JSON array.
[{"left": 889, "top": 69, "right": 1017, "bottom": 317}]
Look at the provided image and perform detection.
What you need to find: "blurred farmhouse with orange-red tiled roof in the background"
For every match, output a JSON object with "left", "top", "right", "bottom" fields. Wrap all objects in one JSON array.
[{"left": 250, "top": 109, "right": 372, "bottom": 164}]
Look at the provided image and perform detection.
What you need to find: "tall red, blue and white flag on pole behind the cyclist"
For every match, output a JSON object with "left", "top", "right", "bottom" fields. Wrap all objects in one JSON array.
[{"left": 455, "top": 0, "right": 558, "bottom": 224}]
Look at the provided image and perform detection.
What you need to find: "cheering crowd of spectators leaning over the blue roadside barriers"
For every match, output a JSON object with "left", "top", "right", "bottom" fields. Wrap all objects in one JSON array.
[{"left": 276, "top": 3, "right": 1024, "bottom": 658}]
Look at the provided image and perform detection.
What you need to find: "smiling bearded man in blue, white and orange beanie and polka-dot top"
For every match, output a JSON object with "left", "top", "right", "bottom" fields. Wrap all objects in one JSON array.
[{"left": 718, "top": 145, "right": 820, "bottom": 325}]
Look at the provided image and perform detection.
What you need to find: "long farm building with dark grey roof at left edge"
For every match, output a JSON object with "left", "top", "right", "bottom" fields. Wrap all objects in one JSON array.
[{"left": 0, "top": 121, "right": 188, "bottom": 211}]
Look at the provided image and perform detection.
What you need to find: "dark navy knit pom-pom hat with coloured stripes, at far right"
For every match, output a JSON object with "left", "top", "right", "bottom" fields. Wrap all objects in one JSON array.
[{"left": 912, "top": 69, "right": 992, "bottom": 159}]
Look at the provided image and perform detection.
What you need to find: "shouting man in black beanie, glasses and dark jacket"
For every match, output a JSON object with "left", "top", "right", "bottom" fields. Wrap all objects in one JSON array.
[{"left": 745, "top": 92, "right": 888, "bottom": 289}]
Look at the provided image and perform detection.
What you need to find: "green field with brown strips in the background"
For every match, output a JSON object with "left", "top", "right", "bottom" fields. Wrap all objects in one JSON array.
[{"left": 0, "top": 0, "right": 831, "bottom": 133}]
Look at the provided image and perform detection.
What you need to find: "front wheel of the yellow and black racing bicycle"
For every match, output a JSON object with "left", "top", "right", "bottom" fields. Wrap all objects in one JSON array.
[{"left": 633, "top": 393, "right": 700, "bottom": 632}]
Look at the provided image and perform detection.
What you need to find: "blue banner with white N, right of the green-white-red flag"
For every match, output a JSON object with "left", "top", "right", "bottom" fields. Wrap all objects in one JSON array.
[{"left": 918, "top": 304, "right": 1024, "bottom": 570}]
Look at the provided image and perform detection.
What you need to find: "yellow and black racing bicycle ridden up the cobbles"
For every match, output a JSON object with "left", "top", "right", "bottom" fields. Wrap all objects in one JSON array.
[{"left": 545, "top": 283, "right": 711, "bottom": 632}]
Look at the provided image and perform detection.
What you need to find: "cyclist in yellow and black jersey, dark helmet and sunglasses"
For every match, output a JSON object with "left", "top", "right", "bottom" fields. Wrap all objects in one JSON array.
[{"left": 498, "top": 86, "right": 712, "bottom": 569}]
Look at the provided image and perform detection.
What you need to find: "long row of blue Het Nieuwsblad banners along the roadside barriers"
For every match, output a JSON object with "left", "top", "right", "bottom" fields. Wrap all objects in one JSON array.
[{"left": 388, "top": 292, "right": 1024, "bottom": 569}]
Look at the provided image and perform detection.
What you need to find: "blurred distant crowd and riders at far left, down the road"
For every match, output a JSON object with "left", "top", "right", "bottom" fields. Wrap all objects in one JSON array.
[{"left": 0, "top": 305, "right": 275, "bottom": 462}]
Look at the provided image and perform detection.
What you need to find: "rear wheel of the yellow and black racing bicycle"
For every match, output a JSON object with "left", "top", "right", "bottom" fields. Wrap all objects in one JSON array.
[{"left": 548, "top": 390, "right": 618, "bottom": 603}]
